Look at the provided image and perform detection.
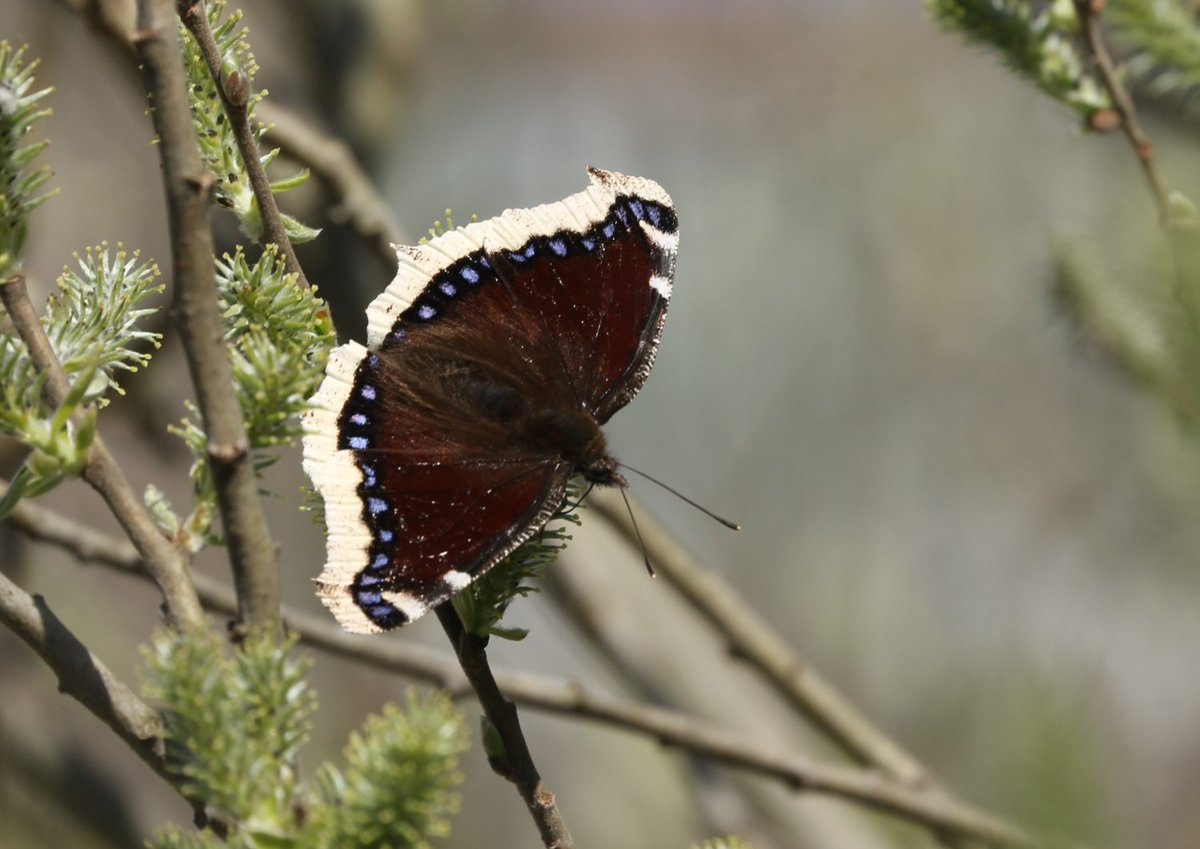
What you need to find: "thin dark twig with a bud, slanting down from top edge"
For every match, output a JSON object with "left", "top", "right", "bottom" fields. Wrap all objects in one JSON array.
[{"left": 178, "top": 0, "right": 308, "bottom": 288}]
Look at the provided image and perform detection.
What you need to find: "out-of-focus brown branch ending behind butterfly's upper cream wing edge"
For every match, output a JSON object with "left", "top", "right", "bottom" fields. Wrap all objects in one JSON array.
[{"left": 256, "top": 101, "right": 410, "bottom": 273}]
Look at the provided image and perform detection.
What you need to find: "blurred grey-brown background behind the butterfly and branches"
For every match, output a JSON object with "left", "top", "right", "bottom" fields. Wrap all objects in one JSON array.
[{"left": 0, "top": 0, "right": 1200, "bottom": 849}]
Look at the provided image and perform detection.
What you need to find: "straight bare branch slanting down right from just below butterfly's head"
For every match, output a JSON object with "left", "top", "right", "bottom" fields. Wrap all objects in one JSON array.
[{"left": 589, "top": 492, "right": 929, "bottom": 789}]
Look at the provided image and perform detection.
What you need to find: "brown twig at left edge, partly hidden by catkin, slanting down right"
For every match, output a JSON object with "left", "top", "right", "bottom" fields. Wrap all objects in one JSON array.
[{"left": 0, "top": 275, "right": 205, "bottom": 630}]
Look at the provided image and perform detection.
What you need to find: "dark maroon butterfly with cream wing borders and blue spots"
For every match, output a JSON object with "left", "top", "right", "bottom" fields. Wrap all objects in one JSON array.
[{"left": 304, "top": 168, "right": 679, "bottom": 633}]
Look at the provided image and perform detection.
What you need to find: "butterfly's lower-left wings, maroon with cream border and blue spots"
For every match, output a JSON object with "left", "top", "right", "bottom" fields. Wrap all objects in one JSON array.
[{"left": 304, "top": 343, "right": 570, "bottom": 633}]
